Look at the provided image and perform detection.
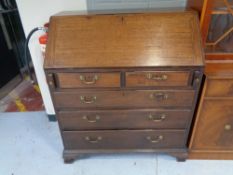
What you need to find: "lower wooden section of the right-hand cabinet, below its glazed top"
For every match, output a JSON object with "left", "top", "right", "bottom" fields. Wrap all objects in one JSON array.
[{"left": 189, "top": 62, "right": 233, "bottom": 159}]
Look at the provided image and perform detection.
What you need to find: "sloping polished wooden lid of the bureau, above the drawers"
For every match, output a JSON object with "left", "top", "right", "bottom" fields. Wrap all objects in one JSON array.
[{"left": 44, "top": 12, "right": 204, "bottom": 68}]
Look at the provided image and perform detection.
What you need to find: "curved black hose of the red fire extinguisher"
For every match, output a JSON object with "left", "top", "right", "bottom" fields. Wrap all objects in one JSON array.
[{"left": 24, "top": 27, "right": 47, "bottom": 83}]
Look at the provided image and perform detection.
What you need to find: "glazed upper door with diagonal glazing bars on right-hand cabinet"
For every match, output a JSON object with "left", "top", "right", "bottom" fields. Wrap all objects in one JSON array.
[{"left": 205, "top": 0, "right": 233, "bottom": 59}]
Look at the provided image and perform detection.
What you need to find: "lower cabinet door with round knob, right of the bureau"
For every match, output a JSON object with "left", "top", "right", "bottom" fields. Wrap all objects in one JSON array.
[{"left": 193, "top": 99, "right": 233, "bottom": 151}]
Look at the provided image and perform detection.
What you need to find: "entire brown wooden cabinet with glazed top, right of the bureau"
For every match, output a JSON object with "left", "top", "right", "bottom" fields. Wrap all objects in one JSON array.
[{"left": 189, "top": 0, "right": 233, "bottom": 159}]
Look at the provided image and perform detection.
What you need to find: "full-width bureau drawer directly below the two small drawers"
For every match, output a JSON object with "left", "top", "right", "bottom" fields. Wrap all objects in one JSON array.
[{"left": 54, "top": 90, "right": 195, "bottom": 108}]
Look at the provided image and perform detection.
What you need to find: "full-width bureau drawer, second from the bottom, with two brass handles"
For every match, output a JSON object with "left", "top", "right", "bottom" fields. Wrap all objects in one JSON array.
[{"left": 58, "top": 110, "right": 191, "bottom": 130}]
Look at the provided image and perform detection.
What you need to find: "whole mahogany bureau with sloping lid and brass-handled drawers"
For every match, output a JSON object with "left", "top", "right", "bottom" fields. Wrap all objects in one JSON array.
[{"left": 44, "top": 12, "right": 204, "bottom": 163}]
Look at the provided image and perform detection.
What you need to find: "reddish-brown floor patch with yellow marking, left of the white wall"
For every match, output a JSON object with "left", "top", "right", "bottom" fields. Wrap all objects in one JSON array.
[{"left": 0, "top": 79, "right": 44, "bottom": 112}]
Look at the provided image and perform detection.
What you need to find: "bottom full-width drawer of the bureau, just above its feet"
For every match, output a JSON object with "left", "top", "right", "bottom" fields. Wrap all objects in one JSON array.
[{"left": 62, "top": 130, "right": 185, "bottom": 150}]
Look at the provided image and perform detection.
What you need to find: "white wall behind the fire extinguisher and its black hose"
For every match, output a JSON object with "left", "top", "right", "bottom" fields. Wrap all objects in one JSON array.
[{"left": 16, "top": 0, "right": 86, "bottom": 115}]
